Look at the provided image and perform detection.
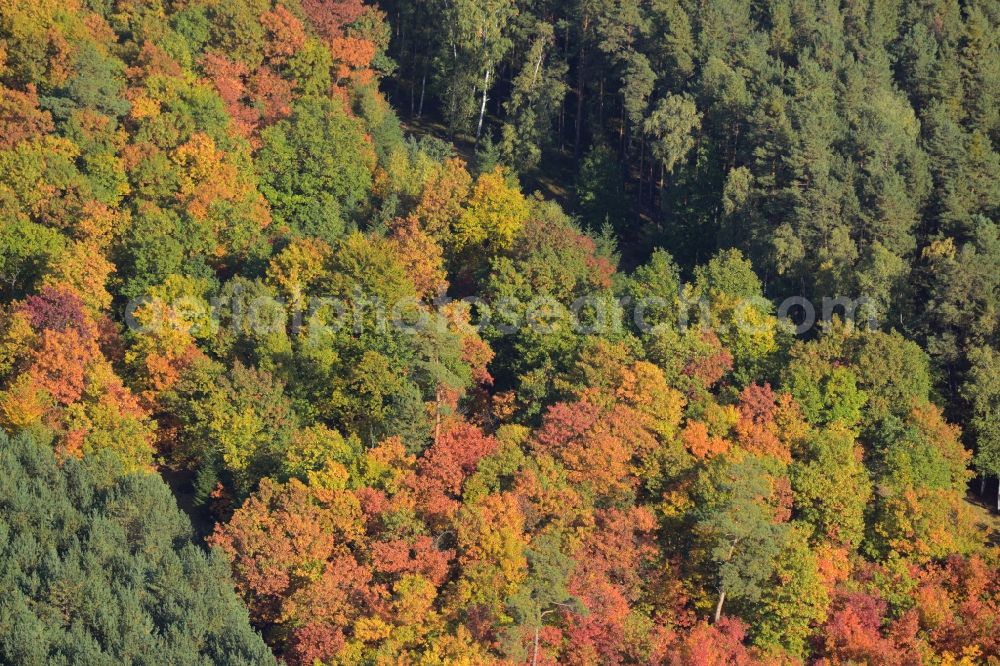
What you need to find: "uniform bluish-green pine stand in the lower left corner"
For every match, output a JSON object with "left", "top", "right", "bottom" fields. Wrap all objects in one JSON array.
[{"left": 0, "top": 433, "right": 274, "bottom": 665}]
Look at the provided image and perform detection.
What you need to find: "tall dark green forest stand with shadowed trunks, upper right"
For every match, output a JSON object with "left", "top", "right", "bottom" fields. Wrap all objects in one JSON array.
[{"left": 381, "top": 0, "right": 1000, "bottom": 488}]
